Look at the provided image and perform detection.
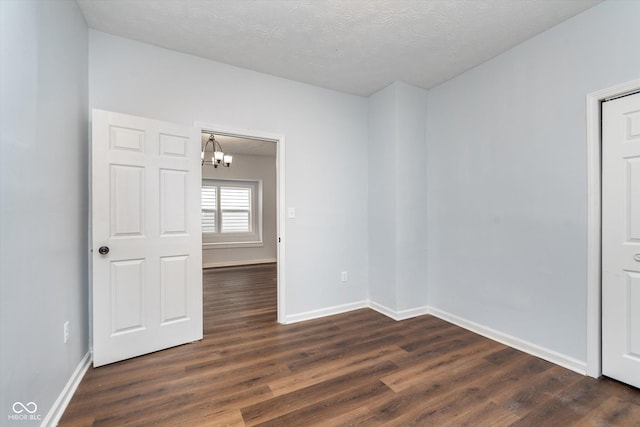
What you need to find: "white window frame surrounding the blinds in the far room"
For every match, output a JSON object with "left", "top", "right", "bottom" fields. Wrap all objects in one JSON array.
[{"left": 200, "top": 177, "right": 264, "bottom": 249}]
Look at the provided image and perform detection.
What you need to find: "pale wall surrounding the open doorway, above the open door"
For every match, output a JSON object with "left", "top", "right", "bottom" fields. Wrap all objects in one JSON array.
[{"left": 89, "top": 31, "right": 368, "bottom": 315}]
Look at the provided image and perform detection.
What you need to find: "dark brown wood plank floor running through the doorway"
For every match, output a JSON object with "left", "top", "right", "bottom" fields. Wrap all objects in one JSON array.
[{"left": 60, "top": 265, "right": 640, "bottom": 427}]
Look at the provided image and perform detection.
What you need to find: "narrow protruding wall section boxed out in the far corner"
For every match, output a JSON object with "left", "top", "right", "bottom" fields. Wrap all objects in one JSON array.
[{"left": 368, "top": 82, "right": 427, "bottom": 317}]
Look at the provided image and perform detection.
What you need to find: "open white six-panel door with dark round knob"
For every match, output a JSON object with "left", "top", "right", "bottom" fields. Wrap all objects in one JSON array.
[{"left": 92, "top": 110, "right": 202, "bottom": 366}]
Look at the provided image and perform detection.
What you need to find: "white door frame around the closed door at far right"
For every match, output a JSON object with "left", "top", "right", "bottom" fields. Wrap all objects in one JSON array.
[{"left": 586, "top": 79, "right": 640, "bottom": 378}]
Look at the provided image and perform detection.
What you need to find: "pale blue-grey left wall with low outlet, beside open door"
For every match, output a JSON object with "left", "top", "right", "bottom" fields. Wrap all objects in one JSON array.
[{"left": 0, "top": 0, "right": 89, "bottom": 425}]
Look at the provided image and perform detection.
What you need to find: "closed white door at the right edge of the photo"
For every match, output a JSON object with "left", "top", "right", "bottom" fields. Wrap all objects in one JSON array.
[{"left": 602, "top": 94, "right": 640, "bottom": 387}]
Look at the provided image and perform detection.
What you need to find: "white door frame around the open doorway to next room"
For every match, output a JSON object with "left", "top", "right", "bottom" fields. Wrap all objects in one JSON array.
[{"left": 194, "top": 122, "right": 286, "bottom": 323}]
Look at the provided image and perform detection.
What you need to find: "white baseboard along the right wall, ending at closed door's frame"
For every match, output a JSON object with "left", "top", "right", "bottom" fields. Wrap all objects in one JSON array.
[{"left": 429, "top": 307, "right": 587, "bottom": 375}]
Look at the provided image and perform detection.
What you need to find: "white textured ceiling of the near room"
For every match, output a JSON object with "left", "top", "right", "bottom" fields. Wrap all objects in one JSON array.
[{"left": 77, "top": 0, "right": 600, "bottom": 96}]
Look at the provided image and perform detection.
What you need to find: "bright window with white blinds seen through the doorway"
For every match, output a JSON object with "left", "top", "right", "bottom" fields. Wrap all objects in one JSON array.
[{"left": 202, "top": 179, "right": 262, "bottom": 246}]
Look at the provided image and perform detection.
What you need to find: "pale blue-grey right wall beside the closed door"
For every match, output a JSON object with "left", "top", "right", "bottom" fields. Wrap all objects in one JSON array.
[{"left": 426, "top": 1, "right": 640, "bottom": 361}]
